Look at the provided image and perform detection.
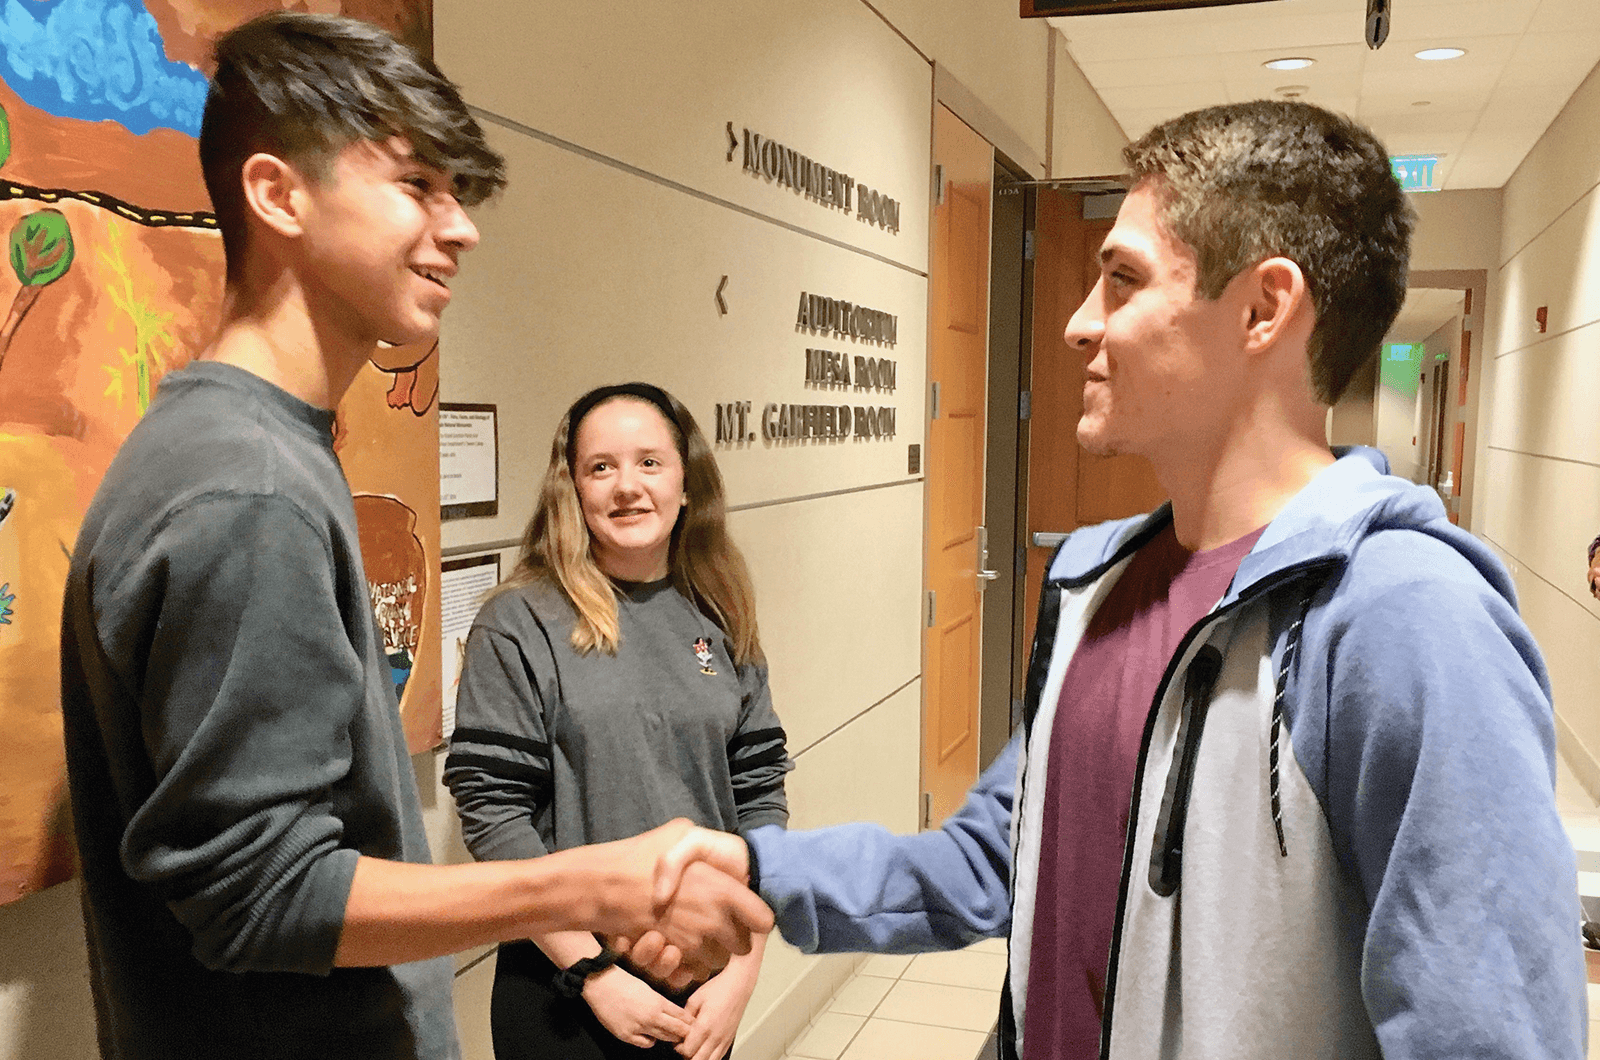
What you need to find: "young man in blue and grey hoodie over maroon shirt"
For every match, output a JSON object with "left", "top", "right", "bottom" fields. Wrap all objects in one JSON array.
[{"left": 649, "top": 102, "right": 1587, "bottom": 1060}]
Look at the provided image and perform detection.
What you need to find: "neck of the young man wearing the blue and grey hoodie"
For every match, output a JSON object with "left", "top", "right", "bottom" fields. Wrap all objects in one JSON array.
[{"left": 1150, "top": 392, "right": 1333, "bottom": 551}]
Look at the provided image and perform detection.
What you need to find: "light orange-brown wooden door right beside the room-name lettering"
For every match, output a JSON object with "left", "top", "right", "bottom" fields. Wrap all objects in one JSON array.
[{"left": 922, "top": 106, "right": 1003, "bottom": 828}]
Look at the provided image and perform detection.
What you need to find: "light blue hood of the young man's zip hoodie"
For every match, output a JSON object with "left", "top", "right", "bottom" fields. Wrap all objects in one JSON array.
[{"left": 1050, "top": 445, "right": 1517, "bottom": 605}]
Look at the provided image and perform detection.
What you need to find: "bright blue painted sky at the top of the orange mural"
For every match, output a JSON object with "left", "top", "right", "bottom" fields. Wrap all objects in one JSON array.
[{"left": 0, "top": 0, "right": 206, "bottom": 136}]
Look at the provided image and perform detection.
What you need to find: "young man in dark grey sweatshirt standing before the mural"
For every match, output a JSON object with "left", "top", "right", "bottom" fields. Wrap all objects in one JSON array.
[{"left": 62, "top": 13, "right": 771, "bottom": 1060}]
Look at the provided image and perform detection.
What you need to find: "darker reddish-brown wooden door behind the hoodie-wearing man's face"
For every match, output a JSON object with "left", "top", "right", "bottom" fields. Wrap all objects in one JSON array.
[{"left": 1022, "top": 187, "right": 1166, "bottom": 645}]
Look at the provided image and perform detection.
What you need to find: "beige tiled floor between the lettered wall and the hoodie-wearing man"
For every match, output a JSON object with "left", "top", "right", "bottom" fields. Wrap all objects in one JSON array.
[{"left": 787, "top": 938, "right": 1005, "bottom": 1060}]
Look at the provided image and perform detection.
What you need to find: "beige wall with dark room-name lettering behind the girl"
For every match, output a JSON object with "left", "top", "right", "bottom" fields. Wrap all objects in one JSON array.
[{"left": 0, "top": 0, "right": 1123, "bottom": 1060}]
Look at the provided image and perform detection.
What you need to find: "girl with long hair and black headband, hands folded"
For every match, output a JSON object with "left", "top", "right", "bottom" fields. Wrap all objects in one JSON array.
[{"left": 445, "top": 383, "right": 792, "bottom": 1060}]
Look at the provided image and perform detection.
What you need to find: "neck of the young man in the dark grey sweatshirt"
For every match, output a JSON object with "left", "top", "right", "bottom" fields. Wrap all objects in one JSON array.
[{"left": 200, "top": 271, "right": 376, "bottom": 410}]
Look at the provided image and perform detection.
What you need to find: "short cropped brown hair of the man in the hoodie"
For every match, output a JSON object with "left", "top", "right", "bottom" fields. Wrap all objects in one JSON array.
[{"left": 1123, "top": 99, "right": 1416, "bottom": 405}]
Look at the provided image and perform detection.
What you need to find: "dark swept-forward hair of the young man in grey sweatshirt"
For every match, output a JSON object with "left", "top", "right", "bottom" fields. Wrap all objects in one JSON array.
[{"left": 200, "top": 11, "right": 506, "bottom": 277}]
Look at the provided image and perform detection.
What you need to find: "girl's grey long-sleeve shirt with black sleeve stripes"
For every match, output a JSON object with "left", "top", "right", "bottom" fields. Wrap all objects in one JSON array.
[{"left": 445, "top": 581, "right": 792, "bottom": 860}]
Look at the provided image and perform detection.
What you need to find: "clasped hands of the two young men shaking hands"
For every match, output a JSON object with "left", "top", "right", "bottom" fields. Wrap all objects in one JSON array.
[{"left": 605, "top": 820, "right": 773, "bottom": 986}]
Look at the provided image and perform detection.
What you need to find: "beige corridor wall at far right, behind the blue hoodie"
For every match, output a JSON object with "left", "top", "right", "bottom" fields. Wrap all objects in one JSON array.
[{"left": 1474, "top": 54, "right": 1600, "bottom": 789}]
